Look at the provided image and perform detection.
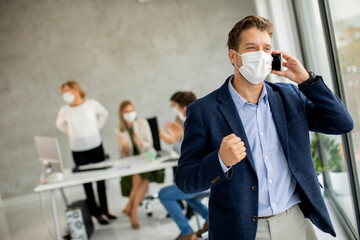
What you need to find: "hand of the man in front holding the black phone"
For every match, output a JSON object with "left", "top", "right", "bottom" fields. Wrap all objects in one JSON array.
[{"left": 271, "top": 50, "right": 310, "bottom": 84}]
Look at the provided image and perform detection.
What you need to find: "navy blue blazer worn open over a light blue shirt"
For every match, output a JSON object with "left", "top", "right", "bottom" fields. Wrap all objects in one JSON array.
[{"left": 175, "top": 77, "right": 354, "bottom": 240}]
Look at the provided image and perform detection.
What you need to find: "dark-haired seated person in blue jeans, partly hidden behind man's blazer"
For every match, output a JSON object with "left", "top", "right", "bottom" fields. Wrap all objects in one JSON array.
[{"left": 159, "top": 92, "right": 209, "bottom": 240}]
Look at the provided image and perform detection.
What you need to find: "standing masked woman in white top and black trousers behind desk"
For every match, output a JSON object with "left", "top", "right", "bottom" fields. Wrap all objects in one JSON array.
[{"left": 56, "top": 81, "right": 116, "bottom": 224}]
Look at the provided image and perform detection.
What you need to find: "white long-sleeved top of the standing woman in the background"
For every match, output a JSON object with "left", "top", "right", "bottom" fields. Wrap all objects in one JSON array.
[{"left": 56, "top": 99, "right": 109, "bottom": 151}]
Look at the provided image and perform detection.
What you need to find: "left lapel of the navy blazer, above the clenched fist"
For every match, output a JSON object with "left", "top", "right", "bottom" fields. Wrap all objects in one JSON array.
[{"left": 218, "top": 77, "right": 256, "bottom": 172}]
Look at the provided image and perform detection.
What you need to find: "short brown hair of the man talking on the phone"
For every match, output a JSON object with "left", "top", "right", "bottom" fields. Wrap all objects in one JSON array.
[{"left": 227, "top": 15, "right": 273, "bottom": 51}]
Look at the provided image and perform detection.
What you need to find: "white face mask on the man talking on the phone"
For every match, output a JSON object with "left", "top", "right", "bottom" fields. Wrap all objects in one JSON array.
[{"left": 234, "top": 50, "right": 272, "bottom": 84}]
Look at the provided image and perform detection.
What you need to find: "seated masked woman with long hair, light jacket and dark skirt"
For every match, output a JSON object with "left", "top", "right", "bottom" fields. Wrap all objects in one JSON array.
[{"left": 115, "top": 101, "right": 164, "bottom": 229}]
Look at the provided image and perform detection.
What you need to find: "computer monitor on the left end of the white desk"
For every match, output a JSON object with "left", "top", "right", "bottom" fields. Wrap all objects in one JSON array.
[{"left": 35, "top": 136, "right": 63, "bottom": 176}]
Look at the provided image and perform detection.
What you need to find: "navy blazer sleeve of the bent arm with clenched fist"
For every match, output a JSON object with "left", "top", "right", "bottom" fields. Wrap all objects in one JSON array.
[{"left": 175, "top": 106, "right": 227, "bottom": 193}]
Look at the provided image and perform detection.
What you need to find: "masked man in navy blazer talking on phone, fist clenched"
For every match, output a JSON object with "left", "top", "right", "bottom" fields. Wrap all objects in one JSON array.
[{"left": 175, "top": 16, "right": 353, "bottom": 240}]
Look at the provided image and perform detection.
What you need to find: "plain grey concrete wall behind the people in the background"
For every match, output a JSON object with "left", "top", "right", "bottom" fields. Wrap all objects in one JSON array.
[{"left": 0, "top": 0, "right": 255, "bottom": 198}]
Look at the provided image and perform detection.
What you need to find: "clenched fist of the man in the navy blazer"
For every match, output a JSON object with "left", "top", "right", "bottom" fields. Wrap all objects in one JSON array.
[{"left": 219, "top": 133, "right": 246, "bottom": 167}]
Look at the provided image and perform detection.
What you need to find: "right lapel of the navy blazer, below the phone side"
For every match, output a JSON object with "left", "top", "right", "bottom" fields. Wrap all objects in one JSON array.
[{"left": 265, "top": 83, "right": 289, "bottom": 159}]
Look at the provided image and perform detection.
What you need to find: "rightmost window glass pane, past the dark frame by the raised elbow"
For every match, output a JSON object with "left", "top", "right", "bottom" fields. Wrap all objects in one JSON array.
[{"left": 328, "top": 0, "right": 360, "bottom": 236}]
